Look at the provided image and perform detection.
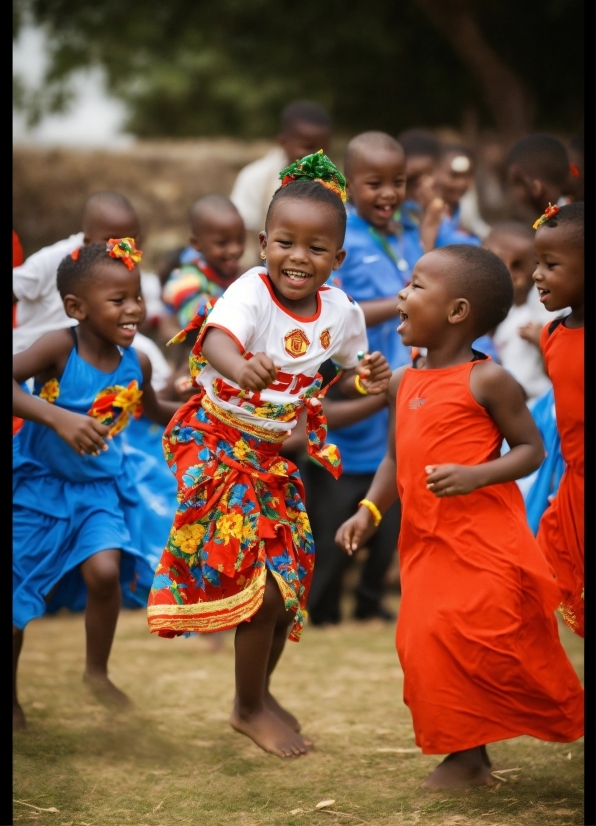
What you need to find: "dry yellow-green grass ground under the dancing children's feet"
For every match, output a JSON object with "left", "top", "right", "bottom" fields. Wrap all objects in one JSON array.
[{"left": 14, "top": 600, "right": 583, "bottom": 826}]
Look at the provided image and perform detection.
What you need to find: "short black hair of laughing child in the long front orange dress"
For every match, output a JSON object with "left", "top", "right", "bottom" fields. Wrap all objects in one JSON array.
[{"left": 434, "top": 244, "right": 513, "bottom": 336}]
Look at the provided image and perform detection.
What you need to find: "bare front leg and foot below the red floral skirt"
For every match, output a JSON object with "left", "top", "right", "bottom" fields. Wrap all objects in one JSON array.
[{"left": 230, "top": 573, "right": 307, "bottom": 757}]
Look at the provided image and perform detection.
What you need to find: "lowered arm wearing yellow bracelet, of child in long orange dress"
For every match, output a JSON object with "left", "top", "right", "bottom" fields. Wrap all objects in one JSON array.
[{"left": 335, "top": 367, "right": 406, "bottom": 556}]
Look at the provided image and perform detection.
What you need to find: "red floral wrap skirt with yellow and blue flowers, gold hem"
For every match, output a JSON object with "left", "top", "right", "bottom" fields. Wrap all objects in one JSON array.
[{"left": 148, "top": 393, "right": 314, "bottom": 641}]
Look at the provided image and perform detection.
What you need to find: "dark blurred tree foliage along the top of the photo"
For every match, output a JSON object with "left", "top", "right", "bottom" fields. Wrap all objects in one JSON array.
[{"left": 14, "top": 0, "right": 583, "bottom": 137}]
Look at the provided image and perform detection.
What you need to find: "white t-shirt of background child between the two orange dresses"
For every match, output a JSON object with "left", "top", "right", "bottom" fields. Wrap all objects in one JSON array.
[{"left": 493, "top": 289, "right": 560, "bottom": 401}]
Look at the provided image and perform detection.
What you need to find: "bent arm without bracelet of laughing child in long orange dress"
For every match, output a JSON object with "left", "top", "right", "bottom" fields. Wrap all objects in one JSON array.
[{"left": 425, "top": 362, "right": 544, "bottom": 496}]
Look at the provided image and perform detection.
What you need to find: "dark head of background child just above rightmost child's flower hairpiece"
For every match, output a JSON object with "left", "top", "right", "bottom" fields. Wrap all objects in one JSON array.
[{"left": 507, "top": 135, "right": 570, "bottom": 218}]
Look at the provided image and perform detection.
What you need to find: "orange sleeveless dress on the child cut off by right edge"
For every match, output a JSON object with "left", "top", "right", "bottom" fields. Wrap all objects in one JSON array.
[{"left": 537, "top": 322, "right": 584, "bottom": 637}]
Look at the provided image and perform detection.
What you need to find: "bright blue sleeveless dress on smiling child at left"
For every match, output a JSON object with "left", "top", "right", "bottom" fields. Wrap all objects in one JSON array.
[{"left": 13, "top": 334, "right": 153, "bottom": 628}]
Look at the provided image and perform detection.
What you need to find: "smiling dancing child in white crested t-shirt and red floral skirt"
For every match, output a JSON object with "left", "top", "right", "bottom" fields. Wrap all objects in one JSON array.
[{"left": 148, "top": 153, "right": 390, "bottom": 757}]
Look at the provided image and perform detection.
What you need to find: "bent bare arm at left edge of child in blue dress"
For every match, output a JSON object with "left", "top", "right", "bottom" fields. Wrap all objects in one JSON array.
[{"left": 12, "top": 330, "right": 111, "bottom": 456}]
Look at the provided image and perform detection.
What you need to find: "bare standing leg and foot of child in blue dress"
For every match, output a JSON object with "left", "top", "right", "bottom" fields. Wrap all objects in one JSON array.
[{"left": 81, "top": 550, "right": 130, "bottom": 706}]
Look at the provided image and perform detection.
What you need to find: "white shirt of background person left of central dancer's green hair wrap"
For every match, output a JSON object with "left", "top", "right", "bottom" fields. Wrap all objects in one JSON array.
[{"left": 230, "top": 147, "right": 289, "bottom": 232}]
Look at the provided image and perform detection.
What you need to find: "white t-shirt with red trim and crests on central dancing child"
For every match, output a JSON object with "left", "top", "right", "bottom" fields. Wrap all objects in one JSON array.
[{"left": 197, "top": 267, "right": 368, "bottom": 432}]
